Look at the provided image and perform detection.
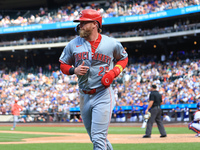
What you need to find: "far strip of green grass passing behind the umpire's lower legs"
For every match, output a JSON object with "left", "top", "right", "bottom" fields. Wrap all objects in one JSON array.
[{"left": 0, "top": 126, "right": 194, "bottom": 134}]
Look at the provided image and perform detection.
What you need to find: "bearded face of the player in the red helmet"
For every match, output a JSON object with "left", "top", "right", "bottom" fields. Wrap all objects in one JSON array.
[{"left": 80, "top": 21, "right": 94, "bottom": 38}]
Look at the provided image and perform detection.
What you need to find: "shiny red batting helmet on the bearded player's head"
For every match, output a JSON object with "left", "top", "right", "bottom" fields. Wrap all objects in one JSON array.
[{"left": 74, "top": 9, "right": 102, "bottom": 28}]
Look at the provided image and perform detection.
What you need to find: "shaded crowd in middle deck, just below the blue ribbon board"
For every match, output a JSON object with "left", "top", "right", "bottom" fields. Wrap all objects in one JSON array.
[{"left": 0, "top": 15, "right": 197, "bottom": 47}]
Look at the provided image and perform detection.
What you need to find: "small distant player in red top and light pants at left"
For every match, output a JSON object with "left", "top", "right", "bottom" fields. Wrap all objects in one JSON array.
[{"left": 11, "top": 100, "right": 23, "bottom": 130}]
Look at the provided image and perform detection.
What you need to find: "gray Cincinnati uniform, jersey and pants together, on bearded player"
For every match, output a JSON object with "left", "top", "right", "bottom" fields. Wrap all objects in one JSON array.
[{"left": 60, "top": 35, "right": 128, "bottom": 150}]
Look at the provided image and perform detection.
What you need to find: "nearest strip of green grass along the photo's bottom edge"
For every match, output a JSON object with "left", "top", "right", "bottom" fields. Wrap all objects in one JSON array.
[{"left": 0, "top": 143, "right": 199, "bottom": 150}]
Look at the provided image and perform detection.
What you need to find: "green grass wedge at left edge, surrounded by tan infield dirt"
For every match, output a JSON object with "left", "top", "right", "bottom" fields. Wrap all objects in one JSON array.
[{"left": 0, "top": 133, "right": 64, "bottom": 142}]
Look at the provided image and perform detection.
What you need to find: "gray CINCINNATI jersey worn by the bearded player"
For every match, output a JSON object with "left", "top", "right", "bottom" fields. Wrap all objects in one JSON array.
[{"left": 60, "top": 35, "right": 128, "bottom": 90}]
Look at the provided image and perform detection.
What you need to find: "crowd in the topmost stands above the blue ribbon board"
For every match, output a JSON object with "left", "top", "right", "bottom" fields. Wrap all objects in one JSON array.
[{"left": 0, "top": 0, "right": 200, "bottom": 27}]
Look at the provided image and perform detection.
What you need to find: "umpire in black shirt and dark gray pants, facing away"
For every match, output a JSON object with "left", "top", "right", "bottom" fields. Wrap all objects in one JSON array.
[{"left": 143, "top": 84, "right": 167, "bottom": 138}]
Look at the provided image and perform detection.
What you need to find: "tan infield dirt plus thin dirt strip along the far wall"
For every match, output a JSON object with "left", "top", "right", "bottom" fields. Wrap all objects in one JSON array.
[{"left": 0, "top": 124, "right": 200, "bottom": 144}]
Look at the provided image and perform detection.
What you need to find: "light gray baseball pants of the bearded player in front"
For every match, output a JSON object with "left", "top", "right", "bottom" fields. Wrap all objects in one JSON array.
[{"left": 80, "top": 88, "right": 115, "bottom": 150}]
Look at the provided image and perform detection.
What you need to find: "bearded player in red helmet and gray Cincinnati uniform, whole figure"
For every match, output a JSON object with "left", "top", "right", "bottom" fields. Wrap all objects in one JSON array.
[{"left": 59, "top": 9, "right": 128, "bottom": 150}]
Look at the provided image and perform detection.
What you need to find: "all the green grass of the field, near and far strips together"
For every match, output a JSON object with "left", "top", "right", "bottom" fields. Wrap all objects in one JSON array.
[{"left": 0, "top": 126, "right": 197, "bottom": 150}]
